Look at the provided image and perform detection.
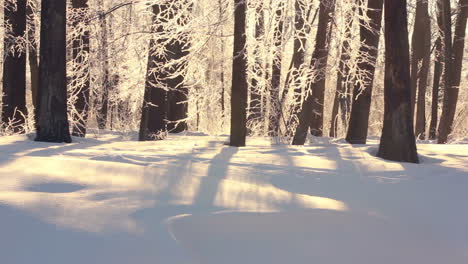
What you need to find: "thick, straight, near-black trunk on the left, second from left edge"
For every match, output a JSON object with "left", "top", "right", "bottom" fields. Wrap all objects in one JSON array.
[{"left": 36, "top": 0, "right": 71, "bottom": 143}]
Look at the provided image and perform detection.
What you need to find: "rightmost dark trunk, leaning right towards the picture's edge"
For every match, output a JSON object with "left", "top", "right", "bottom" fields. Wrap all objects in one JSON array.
[{"left": 438, "top": 0, "right": 468, "bottom": 144}]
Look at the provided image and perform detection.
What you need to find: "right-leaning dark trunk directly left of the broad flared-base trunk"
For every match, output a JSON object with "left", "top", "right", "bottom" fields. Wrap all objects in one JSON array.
[{"left": 346, "top": 0, "right": 383, "bottom": 144}]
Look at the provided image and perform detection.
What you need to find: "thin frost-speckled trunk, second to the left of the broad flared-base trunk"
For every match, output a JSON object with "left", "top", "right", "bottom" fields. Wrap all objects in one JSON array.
[{"left": 329, "top": 10, "right": 353, "bottom": 137}]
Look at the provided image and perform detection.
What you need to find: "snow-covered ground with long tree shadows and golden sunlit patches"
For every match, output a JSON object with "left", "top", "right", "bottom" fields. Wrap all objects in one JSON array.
[{"left": 0, "top": 133, "right": 468, "bottom": 264}]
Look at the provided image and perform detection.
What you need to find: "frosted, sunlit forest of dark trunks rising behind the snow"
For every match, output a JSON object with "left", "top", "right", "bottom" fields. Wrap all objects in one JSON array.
[{"left": 1, "top": 0, "right": 468, "bottom": 162}]
